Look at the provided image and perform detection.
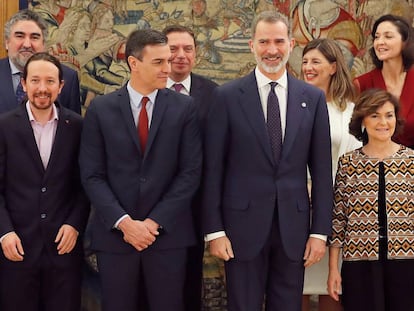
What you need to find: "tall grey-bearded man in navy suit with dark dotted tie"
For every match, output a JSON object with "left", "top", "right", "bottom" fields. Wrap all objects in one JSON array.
[{"left": 203, "top": 11, "right": 333, "bottom": 311}]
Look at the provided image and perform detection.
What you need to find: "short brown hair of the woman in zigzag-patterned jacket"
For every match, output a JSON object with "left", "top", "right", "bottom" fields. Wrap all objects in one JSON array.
[{"left": 349, "top": 88, "right": 404, "bottom": 145}]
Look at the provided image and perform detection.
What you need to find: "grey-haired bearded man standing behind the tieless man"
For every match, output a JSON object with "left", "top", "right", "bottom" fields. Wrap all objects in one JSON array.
[{"left": 0, "top": 10, "right": 81, "bottom": 114}]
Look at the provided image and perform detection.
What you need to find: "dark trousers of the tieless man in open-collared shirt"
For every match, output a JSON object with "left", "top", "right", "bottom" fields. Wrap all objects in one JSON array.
[{"left": 0, "top": 255, "right": 82, "bottom": 311}]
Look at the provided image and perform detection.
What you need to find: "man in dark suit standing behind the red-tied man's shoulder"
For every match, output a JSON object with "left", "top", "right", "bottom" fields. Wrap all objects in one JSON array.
[{"left": 163, "top": 25, "right": 217, "bottom": 311}]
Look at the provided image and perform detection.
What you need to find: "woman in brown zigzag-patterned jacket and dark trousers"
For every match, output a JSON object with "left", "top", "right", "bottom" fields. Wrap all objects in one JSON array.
[{"left": 328, "top": 89, "right": 414, "bottom": 311}]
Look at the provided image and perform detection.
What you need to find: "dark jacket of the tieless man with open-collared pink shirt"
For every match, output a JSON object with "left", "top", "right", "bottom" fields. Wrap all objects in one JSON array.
[{"left": 0, "top": 105, "right": 89, "bottom": 267}]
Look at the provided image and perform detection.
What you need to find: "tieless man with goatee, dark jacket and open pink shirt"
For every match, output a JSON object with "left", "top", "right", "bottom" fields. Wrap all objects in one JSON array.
[{"left": 0, "top": 52, "right": 89, "bottom": 311}]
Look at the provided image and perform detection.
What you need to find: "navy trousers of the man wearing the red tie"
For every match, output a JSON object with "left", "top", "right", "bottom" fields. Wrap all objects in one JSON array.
[{"left": 97, "top": 248, "right": 187, "bottom": 311}]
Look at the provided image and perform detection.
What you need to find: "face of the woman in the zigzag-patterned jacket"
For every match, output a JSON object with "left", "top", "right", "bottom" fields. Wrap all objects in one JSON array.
[{"left": 362, "top": 101, "right": 397, "bottom": 143}]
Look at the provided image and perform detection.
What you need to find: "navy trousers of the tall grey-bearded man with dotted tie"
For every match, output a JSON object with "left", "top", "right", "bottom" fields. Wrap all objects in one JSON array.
[{"left": 225, "top": 222, "right": 304, "bottom": 311}]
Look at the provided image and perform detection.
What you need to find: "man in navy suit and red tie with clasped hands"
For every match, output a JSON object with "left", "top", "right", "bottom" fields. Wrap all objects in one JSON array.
[{"left": 80, "top": 29, "right": 201, "bottom": 311}]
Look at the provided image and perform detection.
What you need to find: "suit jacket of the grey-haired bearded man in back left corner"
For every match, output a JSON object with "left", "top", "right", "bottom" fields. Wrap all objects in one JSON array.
[{"left": 0, "top": 57, "right": 81, "bottom": 114}]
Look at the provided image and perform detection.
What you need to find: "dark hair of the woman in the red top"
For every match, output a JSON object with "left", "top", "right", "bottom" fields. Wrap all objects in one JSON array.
[{"left": 369, "top": 14, "right": 414, "bottom": 70}]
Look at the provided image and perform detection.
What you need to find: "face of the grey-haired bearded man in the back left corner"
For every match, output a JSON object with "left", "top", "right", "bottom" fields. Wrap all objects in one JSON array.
[{"left": 6, "top": 21, "right": 45, "bottom": 71}]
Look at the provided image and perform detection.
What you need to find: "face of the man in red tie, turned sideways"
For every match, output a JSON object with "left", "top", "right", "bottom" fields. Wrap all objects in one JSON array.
[{"left": 128, "top": 44, "right": 171, "bottom": 95}]
